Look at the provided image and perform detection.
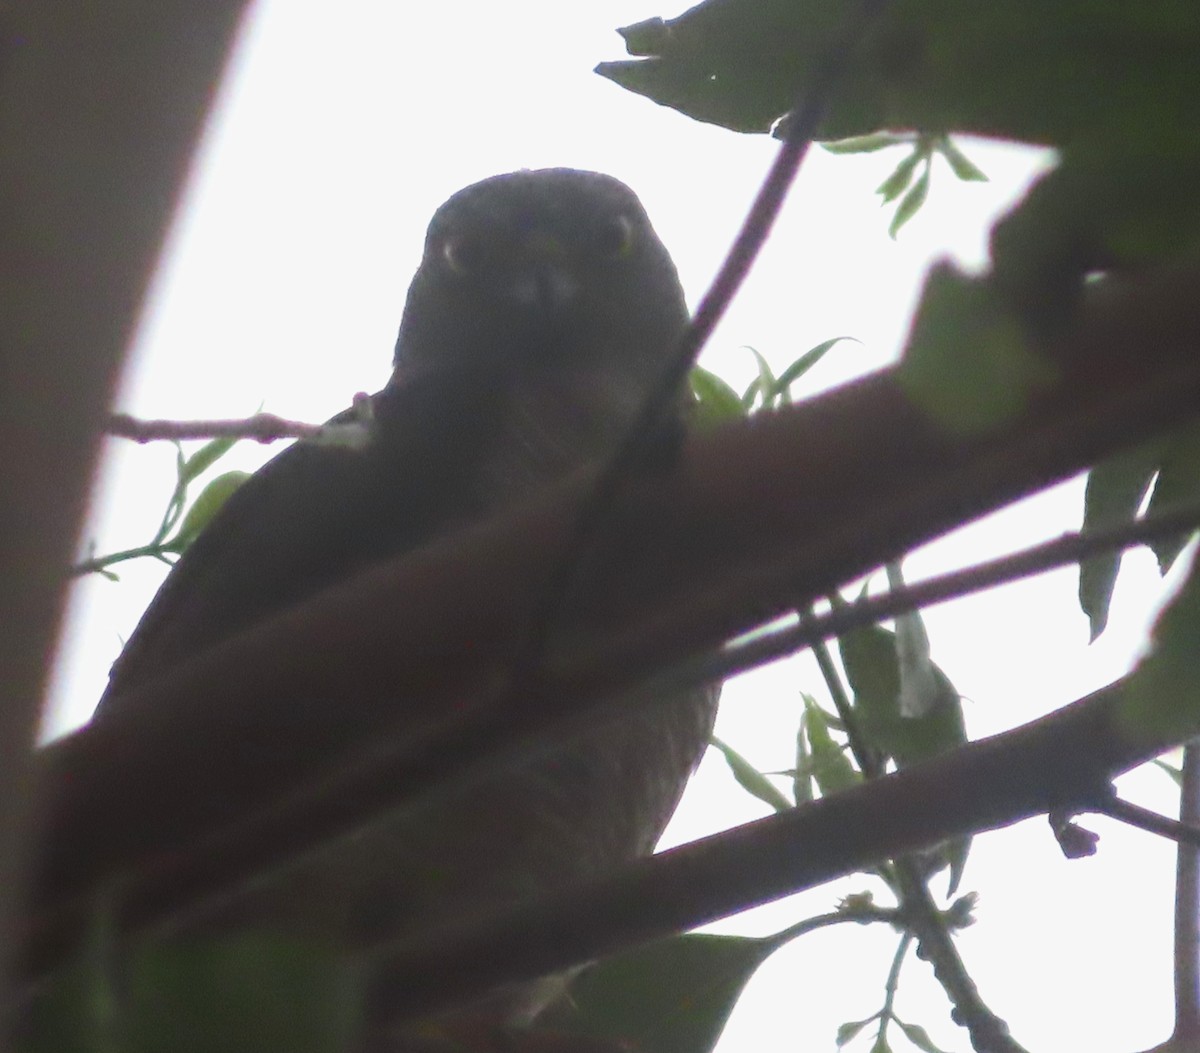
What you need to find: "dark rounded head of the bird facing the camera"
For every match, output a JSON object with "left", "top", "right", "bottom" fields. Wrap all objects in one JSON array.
[{"left": 396, "top": 168, "right": 688, "bottom": 388}]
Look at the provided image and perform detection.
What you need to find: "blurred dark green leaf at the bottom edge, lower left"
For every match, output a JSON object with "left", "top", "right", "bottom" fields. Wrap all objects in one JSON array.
[{"left": 125, "top": 934, "right": 359, "bottom": 1053}]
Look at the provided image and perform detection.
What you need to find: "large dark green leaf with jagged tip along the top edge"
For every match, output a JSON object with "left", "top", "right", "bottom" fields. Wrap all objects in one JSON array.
[{"left": 596, "top": 0, "right": 1200, "bottom": 146}]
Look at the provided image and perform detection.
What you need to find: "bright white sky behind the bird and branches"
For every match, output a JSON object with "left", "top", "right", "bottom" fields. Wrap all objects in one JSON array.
[{"left": 49, "top": 0, "right": 1175, "bottom": 1053}]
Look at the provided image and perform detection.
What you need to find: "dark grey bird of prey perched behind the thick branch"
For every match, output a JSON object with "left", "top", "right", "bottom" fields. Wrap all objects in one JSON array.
[{"left": 94, "top": 168, "right": 719, "bottom": 1049}]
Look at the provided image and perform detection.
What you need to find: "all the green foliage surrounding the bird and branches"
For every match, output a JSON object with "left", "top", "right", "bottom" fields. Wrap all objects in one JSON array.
[{"left": 58, "top": 0, "right": 1200, "bottom": 1053}]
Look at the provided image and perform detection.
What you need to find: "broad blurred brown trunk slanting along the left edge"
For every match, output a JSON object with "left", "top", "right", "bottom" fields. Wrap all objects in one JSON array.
[{"left": 0, "top": 0, "right": 245, "bottom": 1012}]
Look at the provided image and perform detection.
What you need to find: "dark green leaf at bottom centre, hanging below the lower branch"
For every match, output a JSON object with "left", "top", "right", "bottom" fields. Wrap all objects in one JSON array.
[{"left": 549, "top": 933, "right": 775, "bottom": 1053}]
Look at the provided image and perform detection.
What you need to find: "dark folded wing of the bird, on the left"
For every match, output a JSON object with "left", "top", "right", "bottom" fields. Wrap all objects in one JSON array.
[{"left": 97, "top": 374, "right": 494, "bottom": 714}]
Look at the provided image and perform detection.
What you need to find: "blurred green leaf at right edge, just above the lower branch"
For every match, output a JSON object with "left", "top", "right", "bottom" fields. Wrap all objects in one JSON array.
[{"left": 1121, "top": 551, "right": 1200, "bottom": 742}]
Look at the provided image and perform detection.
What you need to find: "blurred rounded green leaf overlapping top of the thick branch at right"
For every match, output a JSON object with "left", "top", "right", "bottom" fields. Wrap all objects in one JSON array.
[{"left": 896, "top": 264, "right": 1058, "bottom": 437}]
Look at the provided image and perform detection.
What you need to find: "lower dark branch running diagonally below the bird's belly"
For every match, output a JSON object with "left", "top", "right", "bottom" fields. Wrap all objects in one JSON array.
[{"left": 360, "top": 684, "right": 1170, "bottom": 1019}]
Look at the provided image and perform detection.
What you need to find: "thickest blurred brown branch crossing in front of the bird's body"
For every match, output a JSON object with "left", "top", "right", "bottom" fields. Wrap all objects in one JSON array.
[{"left": 16, "top": 255, "right": 1200, "bottom": 988}]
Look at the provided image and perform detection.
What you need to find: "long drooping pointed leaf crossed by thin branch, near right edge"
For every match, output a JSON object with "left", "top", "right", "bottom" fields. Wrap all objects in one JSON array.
[{"left": 1079, "top": 443, "right": 1162, "bottom": 642}]
